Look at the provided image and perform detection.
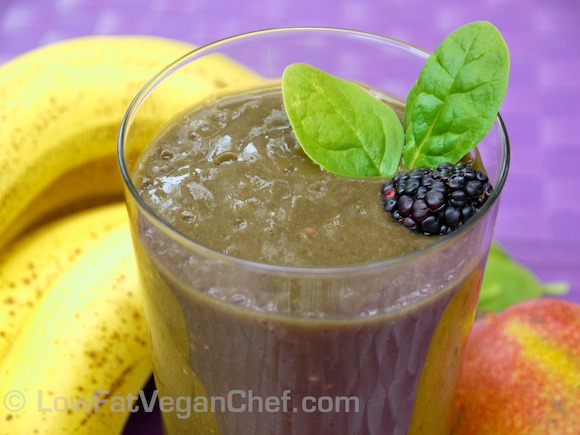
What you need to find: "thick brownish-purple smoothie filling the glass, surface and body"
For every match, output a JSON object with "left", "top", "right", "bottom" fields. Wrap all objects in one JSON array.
[{"left": 133, "top": 82, "right": 487, "bottom": 435}]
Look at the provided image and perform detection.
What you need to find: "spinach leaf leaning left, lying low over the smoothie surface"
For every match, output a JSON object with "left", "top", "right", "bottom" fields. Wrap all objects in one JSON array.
[{"left": 282, "top": 63, "right": 405, "bottom": 177}]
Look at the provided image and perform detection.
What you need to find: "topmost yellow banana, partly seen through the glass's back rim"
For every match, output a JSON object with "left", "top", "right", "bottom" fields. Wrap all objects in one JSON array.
[{"left": 0, "top": 36, "right": 256, "bottom": 248}]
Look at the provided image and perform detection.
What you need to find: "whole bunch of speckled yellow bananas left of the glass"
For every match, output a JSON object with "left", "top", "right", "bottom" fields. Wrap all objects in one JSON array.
[{"left": 0, "top": 36, "right": 255, "bottom": 435}]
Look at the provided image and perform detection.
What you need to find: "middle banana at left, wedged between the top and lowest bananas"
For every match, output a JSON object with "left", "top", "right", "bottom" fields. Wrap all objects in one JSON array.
[{"left": 0, "top": 203, "right": 127, "bottom": 362}]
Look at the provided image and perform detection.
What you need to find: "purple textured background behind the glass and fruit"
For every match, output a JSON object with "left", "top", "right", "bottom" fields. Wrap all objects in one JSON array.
[{"left": 0, "top": 0, "right": 580, "bottom": 435}]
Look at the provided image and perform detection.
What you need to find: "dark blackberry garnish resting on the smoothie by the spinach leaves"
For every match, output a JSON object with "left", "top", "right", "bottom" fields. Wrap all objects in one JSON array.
[{"left": 383, "top": 163, "right": 493, "bottom": 236}]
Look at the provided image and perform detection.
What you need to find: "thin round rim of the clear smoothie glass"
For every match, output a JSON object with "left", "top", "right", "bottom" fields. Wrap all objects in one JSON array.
[{"left": 117, "top": 26, "right": 510, "bottom": 275}]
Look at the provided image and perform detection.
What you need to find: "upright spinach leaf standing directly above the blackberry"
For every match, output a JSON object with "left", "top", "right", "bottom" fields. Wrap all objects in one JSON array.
[{"left": 403, "top": 21, "right": 510, "bottom": 169}]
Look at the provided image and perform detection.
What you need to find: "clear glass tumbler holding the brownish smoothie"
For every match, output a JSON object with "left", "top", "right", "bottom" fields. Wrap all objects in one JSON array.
[{"left": 119, "top": 28, "right": 509, "bottom": 435}]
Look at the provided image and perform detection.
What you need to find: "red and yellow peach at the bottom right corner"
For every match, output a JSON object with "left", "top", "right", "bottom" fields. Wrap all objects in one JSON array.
[{"left": 452, "top": 298, "right": 580, "bottom": 435}]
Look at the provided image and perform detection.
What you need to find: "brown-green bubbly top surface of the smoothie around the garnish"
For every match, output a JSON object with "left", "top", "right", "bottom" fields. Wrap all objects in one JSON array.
[{"left": 135, "top": 83, "right": 438, "bottom": 267}]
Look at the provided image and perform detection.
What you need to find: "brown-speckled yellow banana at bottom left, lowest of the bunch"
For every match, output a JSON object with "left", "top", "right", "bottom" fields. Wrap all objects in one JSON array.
[{"left": 0, "top": 213, "right": 151, "bottom": 435}]
